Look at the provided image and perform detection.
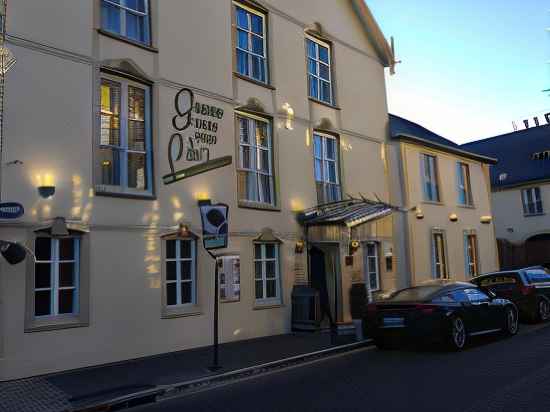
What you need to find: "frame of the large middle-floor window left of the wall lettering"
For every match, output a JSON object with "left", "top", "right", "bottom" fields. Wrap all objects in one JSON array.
[{"left": 95, "top": 72, "right": 153, "bottom": 196}]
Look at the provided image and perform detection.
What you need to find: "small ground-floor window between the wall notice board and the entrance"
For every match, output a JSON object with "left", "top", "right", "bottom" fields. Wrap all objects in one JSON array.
[{"left": 254, "top": 243, "right": 281, "bottom": 304}]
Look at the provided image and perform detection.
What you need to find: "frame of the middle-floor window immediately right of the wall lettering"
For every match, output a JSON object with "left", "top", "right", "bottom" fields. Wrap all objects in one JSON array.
[{"left": 236, "top": 112, "right": 276, "bottom": 206}]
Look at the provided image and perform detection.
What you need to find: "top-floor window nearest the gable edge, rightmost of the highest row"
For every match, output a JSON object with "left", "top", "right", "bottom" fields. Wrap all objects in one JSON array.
[{"left": 306, "top": 37, "right": 333, "bottom": 104}]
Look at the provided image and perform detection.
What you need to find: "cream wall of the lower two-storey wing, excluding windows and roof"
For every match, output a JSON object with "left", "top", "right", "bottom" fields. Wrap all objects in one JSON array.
[{"left": 401, "top": 143, "right": 498, "bottom": 284}]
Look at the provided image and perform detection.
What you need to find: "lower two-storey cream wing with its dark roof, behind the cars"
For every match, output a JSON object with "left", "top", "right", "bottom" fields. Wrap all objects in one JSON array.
[{"left": 390, "top": 115, "right": 498, "bottom": 285}]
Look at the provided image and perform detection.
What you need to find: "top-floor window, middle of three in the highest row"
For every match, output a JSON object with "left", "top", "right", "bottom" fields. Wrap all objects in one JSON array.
[{"left": 234, "top": 3, "right": 267, "bottom": 83}]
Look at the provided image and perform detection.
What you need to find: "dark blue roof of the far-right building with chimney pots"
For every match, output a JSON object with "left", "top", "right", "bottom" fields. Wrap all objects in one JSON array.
[{"left": 461, "top": 125, "right": 550, "bottom": 187}]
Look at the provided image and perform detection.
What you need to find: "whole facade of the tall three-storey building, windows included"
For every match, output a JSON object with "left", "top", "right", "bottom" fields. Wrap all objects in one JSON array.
[{"left": 0, "top": 0, "right": 402, "bottom": 380}]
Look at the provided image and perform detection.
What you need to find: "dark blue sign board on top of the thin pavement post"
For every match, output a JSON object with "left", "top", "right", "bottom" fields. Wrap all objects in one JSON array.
[{"left": 199, "top": 203, "right": 229, "bottom": 250}]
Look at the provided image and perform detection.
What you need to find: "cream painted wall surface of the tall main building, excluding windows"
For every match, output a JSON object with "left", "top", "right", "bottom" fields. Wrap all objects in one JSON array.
[{"left": 0, "top": 0, "right": 393, "bottom": 380}]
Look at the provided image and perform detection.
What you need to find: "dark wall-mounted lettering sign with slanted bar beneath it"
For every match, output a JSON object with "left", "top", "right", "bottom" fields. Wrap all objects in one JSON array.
[{"left": 162, "top": 88, "right": 232, "bottom": 185}]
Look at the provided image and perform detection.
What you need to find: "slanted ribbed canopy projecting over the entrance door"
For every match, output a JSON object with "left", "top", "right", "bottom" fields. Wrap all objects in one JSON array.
[{"left": 298, "top": 199, "right": 395, "bottom": 227}]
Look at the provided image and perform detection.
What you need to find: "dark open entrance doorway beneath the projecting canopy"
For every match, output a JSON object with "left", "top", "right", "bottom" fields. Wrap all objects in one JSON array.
[{"left": 309, "top": 244, "right": 342, "bottom": 326}]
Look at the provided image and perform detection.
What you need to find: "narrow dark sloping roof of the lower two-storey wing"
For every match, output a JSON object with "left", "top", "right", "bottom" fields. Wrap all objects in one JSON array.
[{"left": 390, "top": 114, "right": 495, "bottom": 163}]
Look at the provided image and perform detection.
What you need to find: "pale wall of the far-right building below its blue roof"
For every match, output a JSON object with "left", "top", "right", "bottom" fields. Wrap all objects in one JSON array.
[{"left": 492, "top": 183, "right": 550, "bottom": 243}]
